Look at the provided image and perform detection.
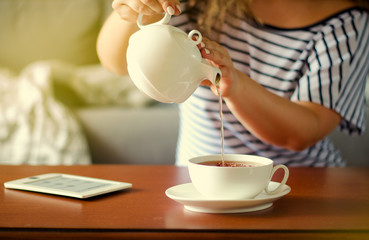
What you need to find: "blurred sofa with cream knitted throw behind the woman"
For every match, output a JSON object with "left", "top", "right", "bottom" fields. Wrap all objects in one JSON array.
[{"left": 0, "top": 0, "right": 369, "bottom": 166}]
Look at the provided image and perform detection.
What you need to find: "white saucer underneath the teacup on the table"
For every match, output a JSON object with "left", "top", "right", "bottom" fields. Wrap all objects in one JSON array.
[{"left": 165, "top": 182, "right": 291, "bottom": 213}]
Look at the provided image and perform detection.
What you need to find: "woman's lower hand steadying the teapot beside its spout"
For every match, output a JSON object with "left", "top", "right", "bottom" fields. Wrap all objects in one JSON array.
[{"left": 198, "top": 37, "right": 239, "bottom": 97}]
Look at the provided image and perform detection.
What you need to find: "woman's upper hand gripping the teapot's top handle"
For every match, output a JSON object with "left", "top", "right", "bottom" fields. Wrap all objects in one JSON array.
[{"left": 112, "top": 0, "right": 181, "bottom": 22}]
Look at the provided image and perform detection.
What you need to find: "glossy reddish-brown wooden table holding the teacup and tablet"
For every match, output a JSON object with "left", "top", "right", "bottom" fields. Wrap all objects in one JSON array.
[{"left": 0, "top": 165, "right": 369, "bottom": 240}]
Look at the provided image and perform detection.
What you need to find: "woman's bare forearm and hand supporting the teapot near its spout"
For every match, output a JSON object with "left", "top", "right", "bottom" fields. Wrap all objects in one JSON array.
[{"left": 201, "top": 39, "right": 341, "bottom": 151}]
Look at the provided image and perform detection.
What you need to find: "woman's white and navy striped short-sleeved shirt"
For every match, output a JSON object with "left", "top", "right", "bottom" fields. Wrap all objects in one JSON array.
[{"left": 171, "top": 2, "right": 369, "bottom": 166}]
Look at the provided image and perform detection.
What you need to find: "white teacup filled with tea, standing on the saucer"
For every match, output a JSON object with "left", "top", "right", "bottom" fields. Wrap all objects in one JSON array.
[{"left": 188, "top": 154, "right": 289, "bottom": 200}]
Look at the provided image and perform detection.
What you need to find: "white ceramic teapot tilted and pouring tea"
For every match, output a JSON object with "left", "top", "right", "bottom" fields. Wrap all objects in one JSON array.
[{"left": 127, "top": 14, "right": 221, "bottom": 103}]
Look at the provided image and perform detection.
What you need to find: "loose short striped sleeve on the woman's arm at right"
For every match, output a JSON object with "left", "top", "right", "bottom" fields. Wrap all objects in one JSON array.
[{"left": 291, "top": 11, "right": 369, "bottom": 135}]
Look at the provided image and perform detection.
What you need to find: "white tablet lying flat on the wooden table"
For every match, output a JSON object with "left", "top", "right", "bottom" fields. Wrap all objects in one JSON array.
[{"left": 4, "top": 173, "right": 132, "bottom": 198}]
